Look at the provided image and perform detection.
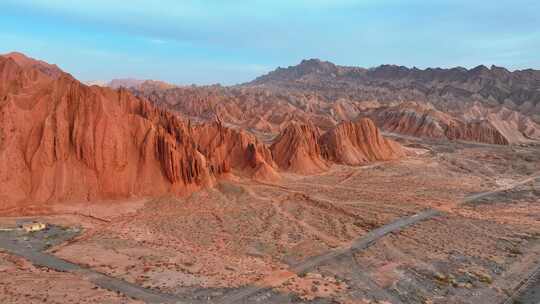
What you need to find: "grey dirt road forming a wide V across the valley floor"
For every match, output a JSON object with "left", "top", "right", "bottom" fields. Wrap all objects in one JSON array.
[{"left": 0, "top": 175, "right": 540, "bottom": 304}]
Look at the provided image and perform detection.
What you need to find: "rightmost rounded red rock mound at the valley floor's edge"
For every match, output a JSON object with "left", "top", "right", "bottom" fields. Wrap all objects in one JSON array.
[{"left": 320, "top": 118, "right": 403, "bottom": 165}]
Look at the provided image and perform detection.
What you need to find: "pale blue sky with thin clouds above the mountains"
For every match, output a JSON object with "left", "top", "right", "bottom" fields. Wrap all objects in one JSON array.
[{"left": 0, "top": 0, "right": 540, "bottom": 84}]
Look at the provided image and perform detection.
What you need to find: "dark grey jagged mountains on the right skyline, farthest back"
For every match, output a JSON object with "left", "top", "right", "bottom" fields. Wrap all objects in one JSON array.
[{"left": 243, "top": 59, "right": 540, "bottom": 122}]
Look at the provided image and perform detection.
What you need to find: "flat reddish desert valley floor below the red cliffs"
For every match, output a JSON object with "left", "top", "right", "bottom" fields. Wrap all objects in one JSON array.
[{"left": 0, "top": 137, "right": 540, "bottom": 304}]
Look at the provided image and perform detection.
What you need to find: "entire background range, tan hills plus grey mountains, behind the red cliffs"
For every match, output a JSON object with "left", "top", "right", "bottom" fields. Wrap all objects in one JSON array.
[{"left": 75, "top": 59, "right": 540, "bottom": 144}]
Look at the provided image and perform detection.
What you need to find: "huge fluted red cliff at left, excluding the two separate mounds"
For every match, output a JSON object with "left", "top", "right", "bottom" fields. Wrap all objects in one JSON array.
[{"left": 0, "top": 56, "right": 275, "bottom": 207}]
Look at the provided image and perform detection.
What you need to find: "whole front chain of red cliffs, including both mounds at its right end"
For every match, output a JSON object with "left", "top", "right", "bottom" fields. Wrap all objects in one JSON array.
[{"left": 0, "top": 54, "right": 410, "bottom": 208}]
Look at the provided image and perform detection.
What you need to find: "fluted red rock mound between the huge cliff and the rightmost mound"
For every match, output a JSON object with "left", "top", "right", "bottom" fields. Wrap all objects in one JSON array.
[{"left": 270, "top": 122, "right": 328, "bottom": 174}]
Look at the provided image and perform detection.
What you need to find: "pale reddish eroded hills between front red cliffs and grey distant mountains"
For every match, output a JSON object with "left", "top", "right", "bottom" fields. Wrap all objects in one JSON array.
[{"left": 132, "top": 76, "right": 540, "bottom": 145}]
